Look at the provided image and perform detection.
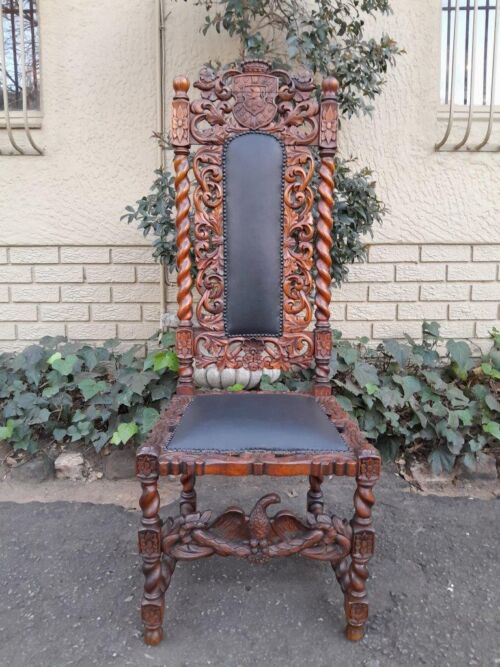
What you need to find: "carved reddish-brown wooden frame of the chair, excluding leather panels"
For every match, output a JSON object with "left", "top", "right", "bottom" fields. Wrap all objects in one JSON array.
[{"left": 137, "top": 60, "right": 380, "bottom": 644}]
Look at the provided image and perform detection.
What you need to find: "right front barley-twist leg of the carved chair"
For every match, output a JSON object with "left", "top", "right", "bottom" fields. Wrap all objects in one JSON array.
[{"left": 346, "top": 476, "right": 376, "bottom": 641}]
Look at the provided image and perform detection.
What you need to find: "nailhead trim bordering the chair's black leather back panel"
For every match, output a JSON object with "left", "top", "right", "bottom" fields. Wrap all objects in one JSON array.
[{"left": 222, "top": 130, "right": 287, "bottom": 338}]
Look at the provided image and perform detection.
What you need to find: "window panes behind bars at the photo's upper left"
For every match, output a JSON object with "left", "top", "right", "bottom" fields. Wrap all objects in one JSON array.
[{"left": 0, "top": 0, "right": 40, "bottom": 112}]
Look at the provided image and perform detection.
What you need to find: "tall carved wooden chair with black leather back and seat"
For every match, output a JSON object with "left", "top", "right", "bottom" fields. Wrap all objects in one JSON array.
[{"left": 137, "top": 61, "right": 380, "bottom": 644}]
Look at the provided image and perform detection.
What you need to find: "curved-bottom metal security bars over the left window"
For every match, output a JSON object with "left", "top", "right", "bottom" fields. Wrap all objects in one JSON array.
[{"left": 0, "top": 0, "right": 43, "bottom": 155}]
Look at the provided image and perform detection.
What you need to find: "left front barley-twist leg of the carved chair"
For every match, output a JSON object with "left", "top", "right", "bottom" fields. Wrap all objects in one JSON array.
[{"left": 139, "top": 476, "right": 165, "bottom": 646}]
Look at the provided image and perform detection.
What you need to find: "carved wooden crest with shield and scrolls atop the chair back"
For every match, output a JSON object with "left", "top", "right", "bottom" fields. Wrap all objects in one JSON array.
[{"left": 190, "top": 60, "right": 319, "bottom": 145}]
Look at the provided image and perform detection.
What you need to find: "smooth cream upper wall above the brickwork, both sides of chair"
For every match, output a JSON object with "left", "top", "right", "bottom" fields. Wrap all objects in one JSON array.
[{"left": 0, "top": 0, "right": 500, "bottom": 244}]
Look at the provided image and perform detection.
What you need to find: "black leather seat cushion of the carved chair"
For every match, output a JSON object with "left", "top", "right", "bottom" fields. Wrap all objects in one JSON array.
[{"left": 167, "top": 393, "right": 347, "bottom": 453}]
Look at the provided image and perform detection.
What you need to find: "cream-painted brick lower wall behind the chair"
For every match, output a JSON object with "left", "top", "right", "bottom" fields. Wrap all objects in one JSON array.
[{"left": 0, "top": 244, "right": 500, "bottom": 350}]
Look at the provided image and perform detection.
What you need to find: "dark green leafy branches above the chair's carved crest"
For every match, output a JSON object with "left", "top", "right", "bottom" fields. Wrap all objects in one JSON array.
[{"left": 197, "top": 0, "right": 402, "bottom": 117}]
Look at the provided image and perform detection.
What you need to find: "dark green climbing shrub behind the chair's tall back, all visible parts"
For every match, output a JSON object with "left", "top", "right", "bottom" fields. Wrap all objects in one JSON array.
[{"left": 122, "top": 0, "right": 402, "bottom": 284}]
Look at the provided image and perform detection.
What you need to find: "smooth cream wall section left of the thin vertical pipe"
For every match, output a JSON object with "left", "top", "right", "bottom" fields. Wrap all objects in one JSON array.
[{"left": 0, "top": 0, "right": 157, "bottom": 245}]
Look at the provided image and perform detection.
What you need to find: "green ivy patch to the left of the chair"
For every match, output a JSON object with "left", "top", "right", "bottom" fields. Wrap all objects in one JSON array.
[{"left": 0, "top": 333, "right": 178, "bottom": 452}]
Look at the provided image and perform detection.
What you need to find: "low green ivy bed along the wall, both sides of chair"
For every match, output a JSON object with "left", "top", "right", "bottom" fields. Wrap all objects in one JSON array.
[{"left": 0, "top": 322, "right": 500, "bottom": 473}]
